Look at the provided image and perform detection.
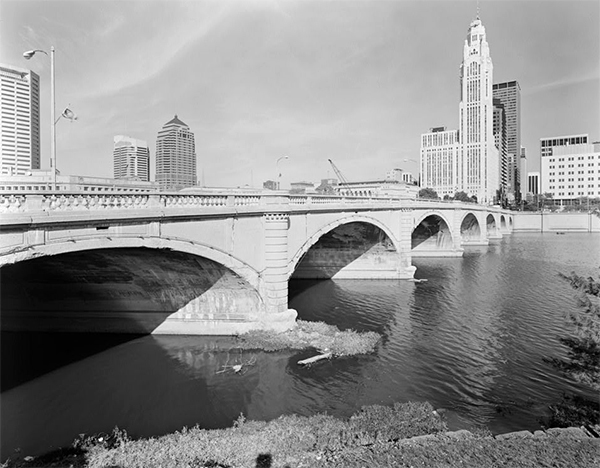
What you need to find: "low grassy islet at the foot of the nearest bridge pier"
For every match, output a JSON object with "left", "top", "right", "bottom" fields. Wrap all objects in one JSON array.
[{"left": 236, "top": 320, "right": 381, "bottom": 356}]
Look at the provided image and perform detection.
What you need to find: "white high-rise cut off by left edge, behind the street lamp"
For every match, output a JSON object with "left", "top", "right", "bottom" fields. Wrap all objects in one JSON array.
[{"left": 0, "top": 64, "right": 40, "bottom": 175}]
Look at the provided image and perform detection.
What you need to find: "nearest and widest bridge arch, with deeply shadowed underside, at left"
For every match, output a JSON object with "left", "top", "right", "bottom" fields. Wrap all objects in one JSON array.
[{"left": 2, "top": 237, "right": 268, "bottom": 334}]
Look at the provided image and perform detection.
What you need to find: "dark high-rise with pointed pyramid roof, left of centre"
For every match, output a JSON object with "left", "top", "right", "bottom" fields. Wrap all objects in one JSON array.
[{"left": 156, "top": 115, "right": 197, "bottom": 190}]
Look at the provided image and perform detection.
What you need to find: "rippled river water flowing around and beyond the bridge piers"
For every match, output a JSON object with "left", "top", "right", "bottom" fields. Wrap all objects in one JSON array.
[{"left": 0, "top": 234, "right": 600, "bottom": 460}]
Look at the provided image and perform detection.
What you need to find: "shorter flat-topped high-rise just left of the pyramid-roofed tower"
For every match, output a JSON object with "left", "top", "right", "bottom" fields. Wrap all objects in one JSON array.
[{"left": 113, "top": 135, "right": 150, "bottom": 182}]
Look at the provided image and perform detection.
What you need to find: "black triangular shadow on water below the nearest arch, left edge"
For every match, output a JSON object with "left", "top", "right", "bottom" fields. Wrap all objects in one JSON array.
[{"left": 0, "top": 332, "right": 142, "bottom": 392}]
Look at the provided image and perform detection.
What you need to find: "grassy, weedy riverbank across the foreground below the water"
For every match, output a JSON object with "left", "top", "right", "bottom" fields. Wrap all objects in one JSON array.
[{"left": 2, "top": 403, "right": 600, "bottom": 468}]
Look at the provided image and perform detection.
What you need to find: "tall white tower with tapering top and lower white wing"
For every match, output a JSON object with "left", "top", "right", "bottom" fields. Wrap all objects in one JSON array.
[{"left": 421, "top": 17, "right": 506, "bottom": 204}]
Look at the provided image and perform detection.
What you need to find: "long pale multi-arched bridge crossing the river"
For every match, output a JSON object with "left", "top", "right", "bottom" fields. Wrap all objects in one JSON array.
[{"left": 0, "top": 192, "right": 513, "bottom": 334}]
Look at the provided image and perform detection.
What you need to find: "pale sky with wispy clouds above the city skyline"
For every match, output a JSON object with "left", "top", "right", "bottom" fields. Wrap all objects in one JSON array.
[{"left": 0, "top": 0, "right": 600, "bottom": 188}]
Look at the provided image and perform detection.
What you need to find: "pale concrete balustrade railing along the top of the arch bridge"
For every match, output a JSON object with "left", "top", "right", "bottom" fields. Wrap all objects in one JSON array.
[{"left": 0, "top": 191, "right": 499, "bottom": 226}]
